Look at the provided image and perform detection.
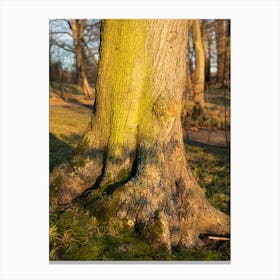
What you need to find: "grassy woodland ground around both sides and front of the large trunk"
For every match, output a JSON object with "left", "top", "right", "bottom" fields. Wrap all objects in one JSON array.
[{"left": 50, "top": 85, "right": 230, "bottom": 261}]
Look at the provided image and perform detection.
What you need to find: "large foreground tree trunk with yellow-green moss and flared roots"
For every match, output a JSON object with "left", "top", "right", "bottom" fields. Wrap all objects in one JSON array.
[{"left": 50, "top": 20, "right": 229, "bottom": 250}]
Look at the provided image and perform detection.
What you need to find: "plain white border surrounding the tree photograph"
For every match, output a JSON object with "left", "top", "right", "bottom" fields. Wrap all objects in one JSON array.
[{"left": 0, "top": 0, "right": 280, "bottom": 280}]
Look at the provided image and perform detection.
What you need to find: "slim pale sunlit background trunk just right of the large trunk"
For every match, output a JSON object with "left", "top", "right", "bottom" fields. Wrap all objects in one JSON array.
[{"left": 192, "top": 19, "right": 205, "bottom": 108}]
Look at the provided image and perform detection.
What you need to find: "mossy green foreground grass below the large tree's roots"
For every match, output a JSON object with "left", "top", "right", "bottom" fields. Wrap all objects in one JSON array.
[{"left": 50, "top": 207, "right": 228, "bottom": 261}]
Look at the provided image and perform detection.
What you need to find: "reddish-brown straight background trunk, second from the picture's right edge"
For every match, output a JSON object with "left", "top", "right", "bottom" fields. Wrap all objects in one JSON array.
[{"left": 216, "top": 20, "right": 225, "bottom": 87}]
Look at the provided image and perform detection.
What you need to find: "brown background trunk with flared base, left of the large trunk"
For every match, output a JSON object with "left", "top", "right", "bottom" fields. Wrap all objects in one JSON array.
[{"left": 71, "top": 19, "right": 93, "bottom": 97}]
